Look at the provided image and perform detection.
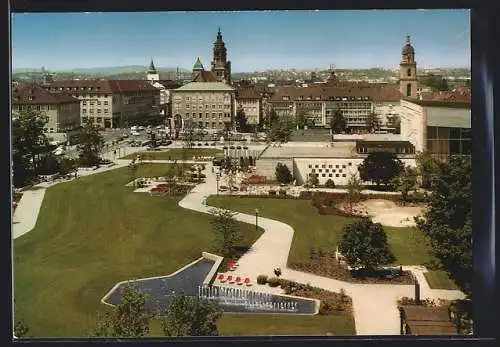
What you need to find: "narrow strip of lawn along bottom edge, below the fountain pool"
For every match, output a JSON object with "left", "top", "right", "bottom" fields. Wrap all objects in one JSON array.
[{"left": 151, "top": 313, "right": 356, "bottom": 336}]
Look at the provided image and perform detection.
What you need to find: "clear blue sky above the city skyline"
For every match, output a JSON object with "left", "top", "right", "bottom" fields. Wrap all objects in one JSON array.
[{"left": 11, "top": 10, "right": 470, "bottom": 72}]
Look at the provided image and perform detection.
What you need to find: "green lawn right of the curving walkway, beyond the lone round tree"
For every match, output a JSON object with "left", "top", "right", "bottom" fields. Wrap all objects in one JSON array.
[{"left": 208, "top": 196, "right": 430, "bottom": 265}]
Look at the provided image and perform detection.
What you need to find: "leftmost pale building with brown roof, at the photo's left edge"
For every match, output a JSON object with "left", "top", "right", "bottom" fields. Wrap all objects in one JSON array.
[{"left": 12, "top": 84, "right": 80, "bottom": 141}]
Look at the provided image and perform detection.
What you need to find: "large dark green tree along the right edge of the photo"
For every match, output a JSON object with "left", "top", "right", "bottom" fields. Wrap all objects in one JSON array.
[{"left": 416, "top": 156, "right": 473, "bottom": 295}]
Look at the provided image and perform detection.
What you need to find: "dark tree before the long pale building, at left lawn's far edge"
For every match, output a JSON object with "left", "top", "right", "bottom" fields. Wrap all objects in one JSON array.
[{"left": 77, "top": 122, "right": 104, "bottom": 167}]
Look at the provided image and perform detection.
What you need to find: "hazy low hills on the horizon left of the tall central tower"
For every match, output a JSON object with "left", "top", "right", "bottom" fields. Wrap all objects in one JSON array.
[{"left": 12, "top": 65, "right": 189, "bottom": 76}]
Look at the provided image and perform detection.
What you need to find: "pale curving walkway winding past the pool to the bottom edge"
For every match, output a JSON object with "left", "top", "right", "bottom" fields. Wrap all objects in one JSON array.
[{"left": 179, "top": 164, "right": 464, "bottom": 335}]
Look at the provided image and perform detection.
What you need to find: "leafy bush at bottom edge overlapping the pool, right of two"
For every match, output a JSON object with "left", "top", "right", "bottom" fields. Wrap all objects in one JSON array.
[{"left": 162, "top": 294, "right": 222, "bottom": 336}]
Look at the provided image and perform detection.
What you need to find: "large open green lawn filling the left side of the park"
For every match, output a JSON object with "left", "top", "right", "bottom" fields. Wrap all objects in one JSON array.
[{"left": 14, "top": 164, "right": 258, "bottom": 337}]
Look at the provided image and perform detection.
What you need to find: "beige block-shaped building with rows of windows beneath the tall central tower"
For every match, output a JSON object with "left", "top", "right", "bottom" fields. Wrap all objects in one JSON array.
[{"left": 170, "top": 82, "right": 235, "bottom": 130}]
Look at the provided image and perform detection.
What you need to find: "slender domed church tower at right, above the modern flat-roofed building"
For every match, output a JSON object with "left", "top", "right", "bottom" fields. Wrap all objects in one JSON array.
[{"left": 399, "top": 35, "right": 418, "bottom": 98}]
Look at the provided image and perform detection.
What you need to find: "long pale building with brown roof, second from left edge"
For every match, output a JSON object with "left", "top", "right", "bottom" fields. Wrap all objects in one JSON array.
[{"left": 43, "top": 79, "right": 162, "bottom": 129}]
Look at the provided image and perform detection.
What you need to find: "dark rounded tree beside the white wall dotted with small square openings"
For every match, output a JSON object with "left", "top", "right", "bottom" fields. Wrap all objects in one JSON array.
[{"left": 358, "top": 152, "right": 404, "bottom": 187}]
